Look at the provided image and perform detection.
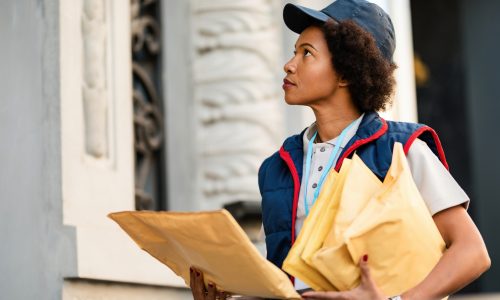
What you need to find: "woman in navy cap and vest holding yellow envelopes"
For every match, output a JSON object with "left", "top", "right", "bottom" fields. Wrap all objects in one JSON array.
[{"left": 192, "top": 0, "right": 490, "bottom": 299}]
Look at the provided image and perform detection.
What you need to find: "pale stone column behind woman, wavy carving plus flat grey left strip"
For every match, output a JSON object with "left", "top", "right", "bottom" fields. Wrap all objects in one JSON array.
[{"left": 164, "top": 0, "right": 284, "bottom": 210}]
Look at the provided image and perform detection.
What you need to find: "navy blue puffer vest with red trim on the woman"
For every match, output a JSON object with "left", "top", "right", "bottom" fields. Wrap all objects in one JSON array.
[{"left": 259, "top": 112, "right": 448, "bottom": 268}]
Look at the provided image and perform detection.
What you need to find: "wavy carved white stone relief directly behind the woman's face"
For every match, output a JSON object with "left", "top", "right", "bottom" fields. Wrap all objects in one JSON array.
[{"left": 192, "top": 0, "right": 283, "bottom": 208}]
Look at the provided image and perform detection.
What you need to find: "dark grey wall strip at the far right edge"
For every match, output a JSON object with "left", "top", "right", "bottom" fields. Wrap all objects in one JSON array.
[{"left": 461, "top": 0, "right": 500, "bottom": 292}]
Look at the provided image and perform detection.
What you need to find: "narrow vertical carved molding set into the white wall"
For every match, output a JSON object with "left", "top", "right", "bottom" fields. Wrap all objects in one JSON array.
[{"left": 82, "top": 0, "right": 109, "bottom": 158}]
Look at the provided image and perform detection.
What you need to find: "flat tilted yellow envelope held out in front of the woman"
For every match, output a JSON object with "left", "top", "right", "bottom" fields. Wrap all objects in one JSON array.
[{"left": 109, "top": 210, "right": 300, "bottom": 299}]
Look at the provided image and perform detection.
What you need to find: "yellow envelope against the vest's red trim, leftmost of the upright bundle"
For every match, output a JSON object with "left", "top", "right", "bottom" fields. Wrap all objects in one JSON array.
[{"left": 283, "top": 160, "right": 350, "bottom": 291}]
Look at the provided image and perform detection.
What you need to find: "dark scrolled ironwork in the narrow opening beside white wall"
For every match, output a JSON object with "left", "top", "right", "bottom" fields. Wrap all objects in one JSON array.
[{"left": 131, "top": 0, "right": 165, "bottom": 210}]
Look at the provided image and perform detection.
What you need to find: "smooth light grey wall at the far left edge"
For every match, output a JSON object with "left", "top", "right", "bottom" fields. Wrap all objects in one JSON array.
[{"left": 0, "top": 0, "right": 75, "bottom": 299}]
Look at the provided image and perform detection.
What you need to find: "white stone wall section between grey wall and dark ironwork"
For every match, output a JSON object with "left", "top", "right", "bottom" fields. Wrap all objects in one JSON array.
[{"left": 59, "top": 0, "right": 184, "bottom": 287}]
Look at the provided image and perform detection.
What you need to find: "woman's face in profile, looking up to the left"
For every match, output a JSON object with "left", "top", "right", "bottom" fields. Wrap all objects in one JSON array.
[{"left": 283, "top": 26, "right": 339, "bottom": 106}]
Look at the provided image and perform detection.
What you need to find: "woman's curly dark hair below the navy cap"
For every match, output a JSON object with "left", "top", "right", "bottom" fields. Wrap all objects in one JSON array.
[{"left": 322, "top": 20, "right": 396, "bottom": 112}]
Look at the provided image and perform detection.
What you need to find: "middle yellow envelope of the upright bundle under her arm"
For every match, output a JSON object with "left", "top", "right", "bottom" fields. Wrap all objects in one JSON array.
[{"left": 308, "top": 155, "right": 382, "bottom": 290}]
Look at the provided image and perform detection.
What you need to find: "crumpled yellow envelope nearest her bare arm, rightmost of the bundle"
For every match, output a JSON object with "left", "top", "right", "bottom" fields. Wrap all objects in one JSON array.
[{"left": 315, "top": 143, "right": 445, "bottom": 295}]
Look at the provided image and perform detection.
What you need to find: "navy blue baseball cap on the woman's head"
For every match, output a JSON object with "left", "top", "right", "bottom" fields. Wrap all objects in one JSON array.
[{"left": 283, "top": 0, "right": 396, "bottom": 62}]
